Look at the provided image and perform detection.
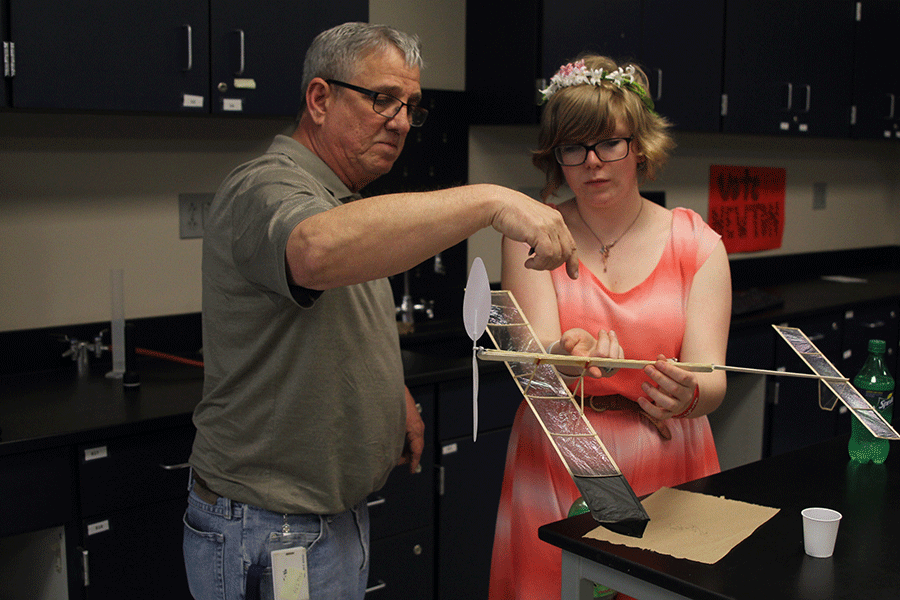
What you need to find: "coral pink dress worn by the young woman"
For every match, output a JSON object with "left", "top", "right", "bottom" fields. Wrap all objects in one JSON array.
[{"left": 490, "top": 208, "right": 719, "bottom": 600}]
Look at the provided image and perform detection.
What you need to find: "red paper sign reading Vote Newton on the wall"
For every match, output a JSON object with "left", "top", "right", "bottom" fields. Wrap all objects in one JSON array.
[{"left": 708, "top": 165, "right": 786, "bottom": 254}]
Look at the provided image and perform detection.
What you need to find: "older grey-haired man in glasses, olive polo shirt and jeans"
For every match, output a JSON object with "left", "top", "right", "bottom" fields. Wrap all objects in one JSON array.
[{"left": 184, "top": 23, "right": 578, "bottom": 600}]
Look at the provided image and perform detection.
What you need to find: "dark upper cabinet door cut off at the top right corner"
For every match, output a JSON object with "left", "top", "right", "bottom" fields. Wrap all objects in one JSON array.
[{"left": 853, "top": 0, "right": 900, "bottom": 140}]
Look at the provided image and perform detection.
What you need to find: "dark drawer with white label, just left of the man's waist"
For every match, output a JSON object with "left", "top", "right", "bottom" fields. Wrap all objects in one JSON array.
[{"left": 78, "top": 425, "right": 194, "bottom": 516}]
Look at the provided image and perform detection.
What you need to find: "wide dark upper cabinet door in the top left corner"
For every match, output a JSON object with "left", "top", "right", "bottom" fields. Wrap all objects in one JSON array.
[{"left": 4, "top": 0, "right": 209, "bottom": 111}]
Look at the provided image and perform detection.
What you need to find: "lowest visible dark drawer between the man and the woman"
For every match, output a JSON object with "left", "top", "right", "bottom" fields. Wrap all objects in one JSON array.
[{"left": 366, "top": 528, "right": 434, "bottom": 600}]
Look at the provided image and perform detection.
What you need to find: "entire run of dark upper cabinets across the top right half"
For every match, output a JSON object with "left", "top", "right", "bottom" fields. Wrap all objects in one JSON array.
[{"left": 466, "top": 0, "right": 900, "bottom": 139}]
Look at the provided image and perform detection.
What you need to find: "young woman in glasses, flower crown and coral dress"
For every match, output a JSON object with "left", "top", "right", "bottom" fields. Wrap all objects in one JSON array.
[{"left": 490, "top": 56, "right": 731, "bottom": 600}]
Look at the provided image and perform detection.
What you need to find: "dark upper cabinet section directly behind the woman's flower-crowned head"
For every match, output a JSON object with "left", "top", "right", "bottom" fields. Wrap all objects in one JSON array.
[{"left": 466, "top": 0, "right": 724, "bottom": 131}]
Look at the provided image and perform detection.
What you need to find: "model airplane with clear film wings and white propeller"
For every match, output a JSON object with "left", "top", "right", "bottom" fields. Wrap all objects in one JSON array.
[{"left": 463, "top": 258, "right": 900, "bottom": 537}]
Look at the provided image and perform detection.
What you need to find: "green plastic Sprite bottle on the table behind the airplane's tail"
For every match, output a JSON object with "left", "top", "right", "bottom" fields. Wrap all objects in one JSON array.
[{"left": 847, "top": 340, "right": 894, "bottom": 465}]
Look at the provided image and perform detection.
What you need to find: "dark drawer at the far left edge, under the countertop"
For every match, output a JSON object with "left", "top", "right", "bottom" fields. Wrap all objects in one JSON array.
[{"left": 0, "top": 448, "right": 75, "bottom": 537}]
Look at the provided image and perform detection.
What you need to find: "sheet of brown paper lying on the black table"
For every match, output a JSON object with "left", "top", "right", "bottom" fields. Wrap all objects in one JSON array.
[{"left": 584, "top": 488, "right": 779, "bottom": 564}]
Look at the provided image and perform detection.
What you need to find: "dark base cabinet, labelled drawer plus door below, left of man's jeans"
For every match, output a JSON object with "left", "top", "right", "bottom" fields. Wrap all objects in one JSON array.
[{"left": 78, "top": 425, "right": 194, "bottom": 600}]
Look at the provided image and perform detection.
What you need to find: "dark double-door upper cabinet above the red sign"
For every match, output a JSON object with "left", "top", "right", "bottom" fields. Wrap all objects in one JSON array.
[{"left": 722, "top": 0, "right": 856, "bottom": 137}]
